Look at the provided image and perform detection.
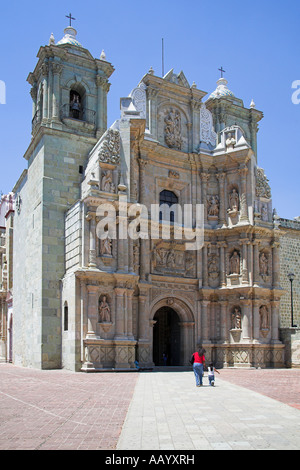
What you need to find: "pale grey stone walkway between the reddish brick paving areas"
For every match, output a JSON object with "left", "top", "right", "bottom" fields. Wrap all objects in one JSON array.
[{"left": 117, "top": 370, "right": 300, "bottom": 450}]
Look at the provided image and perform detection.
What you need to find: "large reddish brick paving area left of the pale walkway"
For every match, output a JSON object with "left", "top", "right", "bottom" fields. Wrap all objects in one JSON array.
[{"left": 0, "top": 364, "right": 138, "bottom": 450}]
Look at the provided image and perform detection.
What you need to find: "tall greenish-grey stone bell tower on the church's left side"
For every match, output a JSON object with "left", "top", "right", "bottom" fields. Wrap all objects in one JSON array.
[{"left": 14, "top": 26, "right": 114, "bottom": 369}]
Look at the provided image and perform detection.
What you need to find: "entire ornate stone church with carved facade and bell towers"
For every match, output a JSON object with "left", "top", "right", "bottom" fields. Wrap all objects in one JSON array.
[{"left": 8, "top": 27, "right": 298, "bottom": 371}]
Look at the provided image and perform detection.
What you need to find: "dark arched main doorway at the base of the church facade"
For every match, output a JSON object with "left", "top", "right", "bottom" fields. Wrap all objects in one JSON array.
[{"left": 153, "top": 307, "right": 181, "bottom": 366}]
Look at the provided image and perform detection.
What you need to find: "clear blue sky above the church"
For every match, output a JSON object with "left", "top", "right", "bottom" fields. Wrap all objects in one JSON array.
[{"left": 0, "top": 0, "right": 300, "bottom": 219}]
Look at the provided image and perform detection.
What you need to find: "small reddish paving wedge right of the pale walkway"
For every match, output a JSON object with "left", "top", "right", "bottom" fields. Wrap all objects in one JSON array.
[{"left": 220, "top": 369, "right": 300, "bottom": 410}]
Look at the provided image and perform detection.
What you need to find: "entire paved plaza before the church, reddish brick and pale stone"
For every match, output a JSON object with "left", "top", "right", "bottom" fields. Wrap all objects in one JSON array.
[{"left": 0, "top": 364, "right": 300, "bottom": 451}]
